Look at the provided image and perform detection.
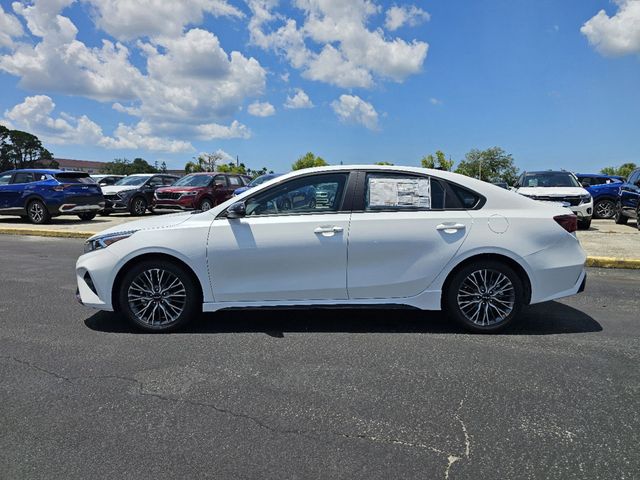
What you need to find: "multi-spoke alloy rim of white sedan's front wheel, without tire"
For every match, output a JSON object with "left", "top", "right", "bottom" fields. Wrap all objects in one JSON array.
[{"left": 127, "top": 268, "right": 187, "bottom": 327}]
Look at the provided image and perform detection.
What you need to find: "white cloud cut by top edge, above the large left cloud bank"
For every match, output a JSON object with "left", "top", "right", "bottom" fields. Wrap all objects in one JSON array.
[{"left": 86, "top": 0, "right": 244, "bottom": 40}]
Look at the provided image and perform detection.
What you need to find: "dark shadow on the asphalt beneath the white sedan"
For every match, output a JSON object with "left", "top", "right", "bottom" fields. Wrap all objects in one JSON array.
[{"left": 84, "top": 302, "right": 602, "bottom": 338}]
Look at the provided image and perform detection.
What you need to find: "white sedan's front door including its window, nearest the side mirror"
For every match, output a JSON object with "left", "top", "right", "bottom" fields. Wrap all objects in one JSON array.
[{"left": 207, "top": 172, "right": 350, "bottom": 302}]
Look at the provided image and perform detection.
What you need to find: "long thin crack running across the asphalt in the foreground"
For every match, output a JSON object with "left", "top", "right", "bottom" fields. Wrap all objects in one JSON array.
[{"left": 0, "top": 355, "right": 471, "bottom": 480}]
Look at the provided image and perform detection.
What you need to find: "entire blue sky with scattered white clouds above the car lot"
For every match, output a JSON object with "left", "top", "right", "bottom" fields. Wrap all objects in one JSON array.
[{"left": 0, "top": 0, "right": 640, "bottom": 172}]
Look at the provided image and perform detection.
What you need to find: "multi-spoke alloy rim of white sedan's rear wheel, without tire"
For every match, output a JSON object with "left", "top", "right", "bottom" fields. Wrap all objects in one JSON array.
[{"left": 457, "top": 269, "right": 516, "bottom": 327}]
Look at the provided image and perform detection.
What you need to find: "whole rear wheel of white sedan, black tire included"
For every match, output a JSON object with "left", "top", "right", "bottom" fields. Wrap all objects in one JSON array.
[{"left": 443, "top": 260, "right": 525, "bottom": 333}]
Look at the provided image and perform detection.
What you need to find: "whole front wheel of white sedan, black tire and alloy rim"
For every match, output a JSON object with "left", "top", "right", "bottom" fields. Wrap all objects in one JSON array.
[{"left": 118, "top": 260, "right": 202, "bottom": 332}]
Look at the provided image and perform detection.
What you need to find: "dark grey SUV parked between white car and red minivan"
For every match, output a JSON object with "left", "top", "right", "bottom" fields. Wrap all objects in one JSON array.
[{"left": 102, "top": 173, "right": 179, "bottom": 215}]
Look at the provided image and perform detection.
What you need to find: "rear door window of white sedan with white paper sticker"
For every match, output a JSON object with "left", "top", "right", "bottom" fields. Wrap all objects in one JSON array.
[{"left": 365, "top": 173, "right": 444, "bottom": 210}]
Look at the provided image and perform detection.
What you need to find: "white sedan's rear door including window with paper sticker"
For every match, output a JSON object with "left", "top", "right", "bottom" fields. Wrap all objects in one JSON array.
[{"left": 347, "top": 172, "right": 472, "bottom": 299}]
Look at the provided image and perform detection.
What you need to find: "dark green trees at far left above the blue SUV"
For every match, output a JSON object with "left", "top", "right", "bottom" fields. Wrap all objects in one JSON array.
[{"left": 0, "top": 125, "right": 56, "bottom": 170}]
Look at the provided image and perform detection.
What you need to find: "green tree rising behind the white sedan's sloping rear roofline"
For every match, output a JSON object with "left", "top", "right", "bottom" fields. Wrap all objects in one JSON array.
[{"left": 456, "top": 147, "right": 518, "bottom": 185}]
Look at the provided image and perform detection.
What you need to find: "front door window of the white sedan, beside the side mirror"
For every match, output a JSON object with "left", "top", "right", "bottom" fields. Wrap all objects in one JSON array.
[{"left": 246, "top": 173, "right": 348, "bottom": 216}]
